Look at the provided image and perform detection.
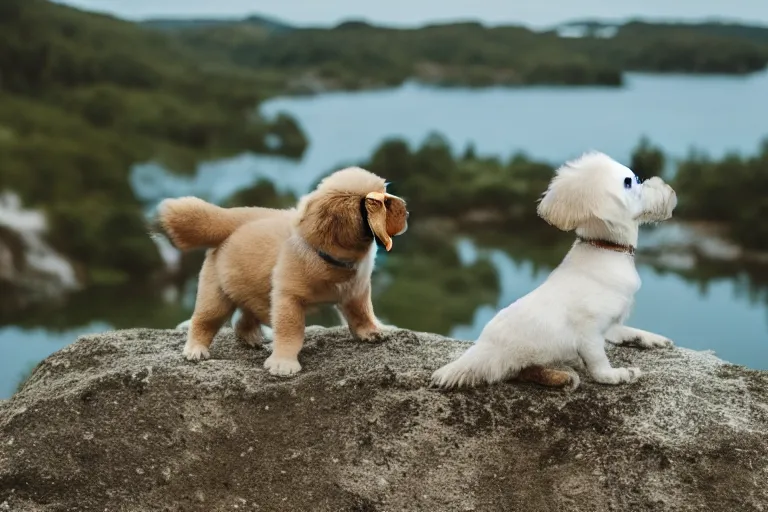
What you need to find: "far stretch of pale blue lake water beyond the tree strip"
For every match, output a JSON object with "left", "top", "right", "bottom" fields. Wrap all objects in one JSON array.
[{"left": 133, "top": 73, "right": 768, "bottom": 200}]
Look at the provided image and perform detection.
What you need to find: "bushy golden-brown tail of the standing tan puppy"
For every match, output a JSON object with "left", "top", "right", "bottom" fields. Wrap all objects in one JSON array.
[{"left": 156, "top": 197, "right": 274, "bottom": 251}]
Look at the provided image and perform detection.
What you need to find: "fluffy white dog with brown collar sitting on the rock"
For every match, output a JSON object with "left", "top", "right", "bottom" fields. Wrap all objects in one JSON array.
[{"left": 432, "top": 152, "right": 677, "bottom": 388}]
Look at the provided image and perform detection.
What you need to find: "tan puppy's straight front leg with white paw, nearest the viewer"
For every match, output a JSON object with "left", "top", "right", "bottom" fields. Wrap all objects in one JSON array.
[{"left": 264, "top": 294, "right": 305, "bottom": 375}]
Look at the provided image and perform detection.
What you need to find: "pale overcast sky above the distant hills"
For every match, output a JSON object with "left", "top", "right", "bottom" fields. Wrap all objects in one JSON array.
[{"left": 52, "top": 0, "right": 768, "bottom": 26}]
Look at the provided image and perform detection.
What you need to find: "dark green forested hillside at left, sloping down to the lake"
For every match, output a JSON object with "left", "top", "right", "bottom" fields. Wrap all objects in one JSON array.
[{"left": 0, "top": 0, "right": 306, "bottom": 281}]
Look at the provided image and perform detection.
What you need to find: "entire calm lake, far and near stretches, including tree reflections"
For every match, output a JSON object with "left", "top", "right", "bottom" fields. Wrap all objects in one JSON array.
[{"left": 0, "top": 73, "right": 768, "bottom": 398}]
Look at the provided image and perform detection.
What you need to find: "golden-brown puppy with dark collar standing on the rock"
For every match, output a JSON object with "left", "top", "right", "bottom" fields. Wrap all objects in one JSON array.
[{"left": 158, "top": 167, "right": 408, "bottom": 375}]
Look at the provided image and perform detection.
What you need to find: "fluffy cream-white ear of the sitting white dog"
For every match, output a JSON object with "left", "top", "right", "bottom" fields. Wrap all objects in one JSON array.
[{"left": 537, "top": 167, "right": 595, "bottom": 231}]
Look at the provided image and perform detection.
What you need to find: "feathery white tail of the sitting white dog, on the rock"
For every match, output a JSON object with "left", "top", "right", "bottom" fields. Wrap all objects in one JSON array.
[{"left": 432, "top": 344, "right": 519, "bottom": 388}]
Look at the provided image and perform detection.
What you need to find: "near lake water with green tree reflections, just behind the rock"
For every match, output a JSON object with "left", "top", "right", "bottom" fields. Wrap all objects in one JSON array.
[{"left": 0, "top": 222, "right": 768, "bottom": 398}]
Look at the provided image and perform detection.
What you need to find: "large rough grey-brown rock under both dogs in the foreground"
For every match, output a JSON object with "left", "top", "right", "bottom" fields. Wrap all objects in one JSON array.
[{"left": 0, "top": 328, "right": 768, "bottom": 512}]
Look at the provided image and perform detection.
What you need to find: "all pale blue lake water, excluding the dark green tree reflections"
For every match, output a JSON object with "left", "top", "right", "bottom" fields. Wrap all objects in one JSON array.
[{"left": 0, "top": 73, "right": 768, "bottom": 398}]
